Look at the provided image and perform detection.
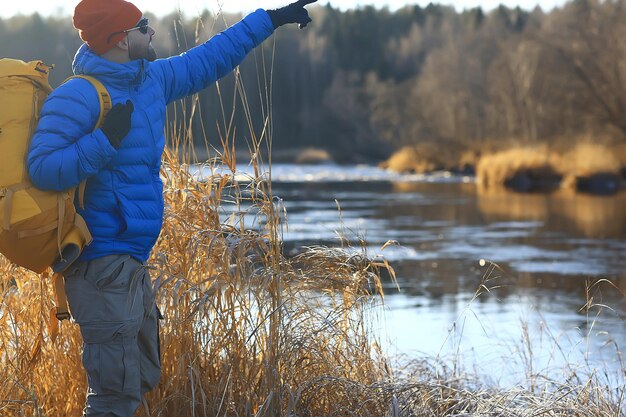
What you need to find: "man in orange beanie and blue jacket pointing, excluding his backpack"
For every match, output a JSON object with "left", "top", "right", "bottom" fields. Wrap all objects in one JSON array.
[{"left": 28, "top": 0, "right": 316, "bottom": 417}]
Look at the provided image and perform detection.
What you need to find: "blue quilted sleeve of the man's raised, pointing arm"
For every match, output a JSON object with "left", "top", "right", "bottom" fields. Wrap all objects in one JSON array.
[{"left": 151, "top": 9, "right": 274, "bottom": 103}]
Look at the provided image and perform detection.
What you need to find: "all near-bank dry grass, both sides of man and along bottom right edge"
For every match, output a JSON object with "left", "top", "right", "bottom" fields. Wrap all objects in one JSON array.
[{"left": 0, "top": 147, "right": 626, "bottom": 417}]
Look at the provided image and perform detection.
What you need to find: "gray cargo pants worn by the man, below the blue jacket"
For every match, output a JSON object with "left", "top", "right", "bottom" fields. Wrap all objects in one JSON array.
[{"left": 64, "top": 255, "right": 161, "bottom": 417}]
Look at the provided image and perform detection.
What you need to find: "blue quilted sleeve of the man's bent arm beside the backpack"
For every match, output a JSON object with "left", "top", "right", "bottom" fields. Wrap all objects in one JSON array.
[{"left": 27, "top": 79, "right": 117, "bottom": 191}]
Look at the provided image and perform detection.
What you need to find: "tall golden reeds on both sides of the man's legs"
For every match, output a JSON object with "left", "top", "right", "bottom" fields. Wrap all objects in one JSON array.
[{"left": 0, "top": 141, "right": 391, "bottom": 416}]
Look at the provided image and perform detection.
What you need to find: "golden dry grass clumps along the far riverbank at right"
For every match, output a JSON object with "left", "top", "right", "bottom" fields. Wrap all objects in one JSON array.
[{"left": 379, "top": 140, "right": 626, "bottom": 195}]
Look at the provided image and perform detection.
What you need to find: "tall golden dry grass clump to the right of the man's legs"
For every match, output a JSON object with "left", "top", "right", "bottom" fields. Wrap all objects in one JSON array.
[{"left": 143, "top": 147, "right": 394, "bottom": 416}]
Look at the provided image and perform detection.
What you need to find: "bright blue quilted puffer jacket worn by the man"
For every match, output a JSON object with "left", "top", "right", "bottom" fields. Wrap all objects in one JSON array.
[{"left": 28, "top": 10, "right": 274, "bottom": 262}]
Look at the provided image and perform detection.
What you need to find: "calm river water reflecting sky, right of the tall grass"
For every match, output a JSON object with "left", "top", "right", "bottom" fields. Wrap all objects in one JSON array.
[{"left": 193, "top": 164, "right": 626, "bottom": 386}]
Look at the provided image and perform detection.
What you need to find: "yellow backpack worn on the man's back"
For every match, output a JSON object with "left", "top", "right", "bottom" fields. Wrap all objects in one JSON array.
[{"left": 0, "top": 58, "right": 111, "bottom": 318}]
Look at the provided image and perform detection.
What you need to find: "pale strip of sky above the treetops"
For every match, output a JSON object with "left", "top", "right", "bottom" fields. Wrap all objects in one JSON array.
[{"left": 0, "top": 0, "right": 565, "bottom": 18}]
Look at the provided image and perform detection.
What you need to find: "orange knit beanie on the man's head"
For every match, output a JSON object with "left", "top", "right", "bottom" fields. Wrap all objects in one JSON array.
[{"left": 73, "top": 0, "right": 142, "bottom": 55}]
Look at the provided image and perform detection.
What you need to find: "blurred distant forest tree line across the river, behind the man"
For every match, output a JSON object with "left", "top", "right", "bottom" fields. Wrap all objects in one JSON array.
[{"left": 0, "top": 0, "right": 626, "bottom": 162}]
